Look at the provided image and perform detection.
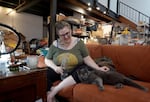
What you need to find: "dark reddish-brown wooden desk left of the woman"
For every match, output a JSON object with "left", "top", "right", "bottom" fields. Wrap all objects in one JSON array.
[{"left": 0, "top": 68, "right": 47, "bottom": 102}]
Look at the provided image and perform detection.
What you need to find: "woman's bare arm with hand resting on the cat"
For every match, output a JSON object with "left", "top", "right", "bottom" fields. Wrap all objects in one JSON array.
[{"left": 83, "top": 56, "right": 109, "bottom": 72}]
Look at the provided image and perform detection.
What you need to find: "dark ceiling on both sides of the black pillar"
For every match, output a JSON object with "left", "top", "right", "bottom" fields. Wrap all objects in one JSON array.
[{"left": 0, "top": 0, "right": 116, "bottom": 22}]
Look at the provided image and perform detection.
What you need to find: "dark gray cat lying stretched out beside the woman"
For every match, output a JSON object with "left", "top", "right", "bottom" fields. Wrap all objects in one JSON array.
[{"left": 77, "top": 57, "right": 148, "bottom": 92}]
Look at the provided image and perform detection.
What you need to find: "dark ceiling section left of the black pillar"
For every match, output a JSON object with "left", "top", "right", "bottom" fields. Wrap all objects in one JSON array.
[{"left": 0, "top": 0, "right": 65, "bottom": 16}]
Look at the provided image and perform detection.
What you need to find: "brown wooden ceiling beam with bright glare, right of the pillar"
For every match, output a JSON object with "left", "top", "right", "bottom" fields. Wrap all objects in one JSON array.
[{"left": 59, "top": 0, "right": 114, "bottom": 22}]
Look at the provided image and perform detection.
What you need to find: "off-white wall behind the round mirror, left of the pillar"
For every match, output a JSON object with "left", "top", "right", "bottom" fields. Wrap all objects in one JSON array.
[{"left": 0, "top": 7, "right": 43, "bottom": 41}]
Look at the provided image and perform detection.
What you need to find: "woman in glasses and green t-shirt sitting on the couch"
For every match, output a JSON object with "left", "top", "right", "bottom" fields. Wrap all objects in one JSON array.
[{"left": 45, "top": 21, "right": 109, "bottom": 102}]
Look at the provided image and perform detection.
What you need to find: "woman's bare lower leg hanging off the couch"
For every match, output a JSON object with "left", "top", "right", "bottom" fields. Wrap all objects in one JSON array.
[{"left": 47, "top": 76, "right": 76, "bottom": 102}]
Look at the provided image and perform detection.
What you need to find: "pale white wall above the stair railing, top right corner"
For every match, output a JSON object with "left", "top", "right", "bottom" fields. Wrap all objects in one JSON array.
[{"left": 120, "top": 0, "right": 150, "bottom": 16}]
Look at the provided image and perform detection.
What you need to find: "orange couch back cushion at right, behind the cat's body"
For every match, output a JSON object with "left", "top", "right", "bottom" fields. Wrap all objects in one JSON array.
[{"left": 102, "top": 45, "right": 150, "bottom": 82}]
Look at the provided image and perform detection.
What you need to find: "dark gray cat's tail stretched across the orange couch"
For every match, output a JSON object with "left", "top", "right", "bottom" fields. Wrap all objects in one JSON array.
[{"left": 124, "top": 78, "right": 149, "bottom": 92}]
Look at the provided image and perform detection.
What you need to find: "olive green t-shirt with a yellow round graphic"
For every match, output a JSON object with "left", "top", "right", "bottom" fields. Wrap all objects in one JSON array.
[{"left": 46, "top": 40, "right": 89, "bottom": 69}]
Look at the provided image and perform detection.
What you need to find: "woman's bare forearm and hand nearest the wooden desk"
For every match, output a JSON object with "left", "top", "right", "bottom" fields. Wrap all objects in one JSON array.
[{"left": 45, "top": 58, "right": 63, "bottom": 74}]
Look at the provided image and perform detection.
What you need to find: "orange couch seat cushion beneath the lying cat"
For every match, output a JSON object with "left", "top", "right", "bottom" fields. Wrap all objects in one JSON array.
[{"left": 73, "top": 82, "right": 150, "bottom": 102}]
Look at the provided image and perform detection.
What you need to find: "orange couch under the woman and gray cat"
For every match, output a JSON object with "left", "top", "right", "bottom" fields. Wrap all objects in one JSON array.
[{"left": 37, "top": 44, "right": 150, "bottom": 102}]
